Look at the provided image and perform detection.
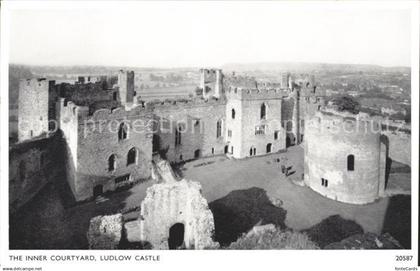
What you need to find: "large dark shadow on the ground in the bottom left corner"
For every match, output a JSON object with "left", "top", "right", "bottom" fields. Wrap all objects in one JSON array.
[{"left": 9, "top": 182, "right": 132, "bottom": 249}]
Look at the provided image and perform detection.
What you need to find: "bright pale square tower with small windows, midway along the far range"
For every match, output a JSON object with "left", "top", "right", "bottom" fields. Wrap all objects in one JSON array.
[{"left": 225, "top": 87, "right": 286, "bottom": 158}]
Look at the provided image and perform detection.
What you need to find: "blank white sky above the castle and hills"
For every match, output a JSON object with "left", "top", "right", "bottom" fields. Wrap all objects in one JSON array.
[{"left": 9, "top": 2, "right": 411, "bottom": 67}]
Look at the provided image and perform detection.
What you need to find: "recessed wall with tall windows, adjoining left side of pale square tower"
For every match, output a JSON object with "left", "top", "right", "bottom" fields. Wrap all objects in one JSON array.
[{"left": 153, "top": 101, "right": 225, "bottom": 162}]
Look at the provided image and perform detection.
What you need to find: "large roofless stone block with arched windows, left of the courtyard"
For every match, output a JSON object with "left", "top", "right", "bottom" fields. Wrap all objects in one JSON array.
[{"left": 59, "top": 101, "right": 153, "bottom": 201}]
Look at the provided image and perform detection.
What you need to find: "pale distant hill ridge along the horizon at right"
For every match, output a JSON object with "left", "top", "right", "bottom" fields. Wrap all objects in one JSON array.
[{"left": 222, "top": 62, "right": 411, "bottom": 73}]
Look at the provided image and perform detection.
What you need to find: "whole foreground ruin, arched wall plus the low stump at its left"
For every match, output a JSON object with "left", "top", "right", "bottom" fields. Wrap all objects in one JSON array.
[{"left": 87, "top": 160, "right": 218, "bottom": 249}]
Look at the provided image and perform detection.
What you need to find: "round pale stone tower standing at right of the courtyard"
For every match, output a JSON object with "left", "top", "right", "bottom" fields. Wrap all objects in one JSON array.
[{"left": 304, "top": 112, "right": 383, "bottom": 204}]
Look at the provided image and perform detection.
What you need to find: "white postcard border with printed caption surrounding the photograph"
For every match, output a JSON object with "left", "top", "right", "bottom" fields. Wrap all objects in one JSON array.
[{"left": 0, "top": 1, "right": 419, "bottom": 271}]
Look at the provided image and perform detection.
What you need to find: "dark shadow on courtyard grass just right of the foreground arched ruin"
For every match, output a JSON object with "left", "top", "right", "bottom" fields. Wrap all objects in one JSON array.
[{"left": 209, "top": 187, "right": 286, "bottom": 246}]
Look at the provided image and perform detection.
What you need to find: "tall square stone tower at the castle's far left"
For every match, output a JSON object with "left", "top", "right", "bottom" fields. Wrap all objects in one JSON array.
[{"left": 18, "top": 78, "right": 48, "bottom": 141}]
